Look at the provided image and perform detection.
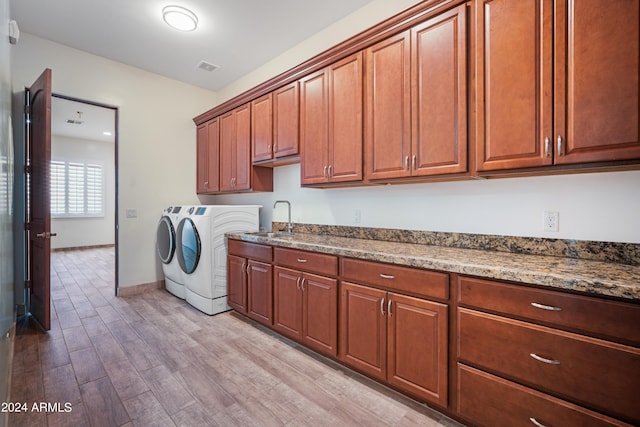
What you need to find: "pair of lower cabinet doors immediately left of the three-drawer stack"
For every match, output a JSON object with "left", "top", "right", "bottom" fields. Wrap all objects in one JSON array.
[{"left": 340, "top": 282, "right": 448, "bottom": 407}]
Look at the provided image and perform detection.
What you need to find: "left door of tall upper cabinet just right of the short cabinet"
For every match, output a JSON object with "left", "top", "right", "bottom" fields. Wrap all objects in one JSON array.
[{"left": 300, "top": 71, "right": 329, "bottom": 184}]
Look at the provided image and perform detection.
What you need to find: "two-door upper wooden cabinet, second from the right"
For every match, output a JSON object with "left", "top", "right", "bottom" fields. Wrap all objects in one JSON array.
[{"left": 365, "top": 6, "right": 468, "bottom": 180}]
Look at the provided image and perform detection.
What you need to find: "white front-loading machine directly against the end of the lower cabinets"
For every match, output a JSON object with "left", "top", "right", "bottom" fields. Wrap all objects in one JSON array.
[{"left": 176, "top": 205, "right": 261, "bottom": 315}]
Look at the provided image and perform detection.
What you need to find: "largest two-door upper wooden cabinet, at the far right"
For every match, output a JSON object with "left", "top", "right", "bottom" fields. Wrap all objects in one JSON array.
[{"left": 475, "top": 0, "right": 640, "bottom": 171}]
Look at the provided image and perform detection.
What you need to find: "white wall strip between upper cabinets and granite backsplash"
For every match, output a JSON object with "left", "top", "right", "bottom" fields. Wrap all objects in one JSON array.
[{"left": 215, "top": 165, "right": 640, "bottom": 243}]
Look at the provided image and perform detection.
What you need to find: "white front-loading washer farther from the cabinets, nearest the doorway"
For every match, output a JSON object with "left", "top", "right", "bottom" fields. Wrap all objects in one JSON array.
[{"left": 156, "top": 206, "right": 185, "bottom": 299}]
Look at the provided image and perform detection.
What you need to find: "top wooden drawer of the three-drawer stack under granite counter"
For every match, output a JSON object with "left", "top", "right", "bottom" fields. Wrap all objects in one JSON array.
[{"left": 458, "top": 277, "right": 640, "bottom": 346}]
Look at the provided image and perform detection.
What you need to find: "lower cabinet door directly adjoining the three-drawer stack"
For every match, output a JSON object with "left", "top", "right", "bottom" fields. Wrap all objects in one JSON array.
[{"left": 387, "top": 293, "right": 448, "bottom": 407}]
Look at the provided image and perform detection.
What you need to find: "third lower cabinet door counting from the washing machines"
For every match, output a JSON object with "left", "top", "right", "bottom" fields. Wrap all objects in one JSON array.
[{"left": 273, "top": 267, "right": 302, "bottom": 339}]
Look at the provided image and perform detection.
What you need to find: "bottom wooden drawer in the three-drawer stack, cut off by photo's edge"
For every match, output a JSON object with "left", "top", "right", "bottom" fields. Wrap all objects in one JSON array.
[{"left": 457, "top": 364, "right": 629, "bottom": 427}]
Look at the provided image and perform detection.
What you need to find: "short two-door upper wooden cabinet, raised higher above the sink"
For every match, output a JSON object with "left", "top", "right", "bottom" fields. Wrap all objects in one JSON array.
[{"left": 251, "top": 82, "right": 300, "bottom": 163}]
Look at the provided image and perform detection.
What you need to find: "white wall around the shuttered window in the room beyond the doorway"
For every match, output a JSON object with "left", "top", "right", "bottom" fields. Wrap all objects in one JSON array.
[{"left": 51, "top": 135, "right": 116, "bottom": 249}]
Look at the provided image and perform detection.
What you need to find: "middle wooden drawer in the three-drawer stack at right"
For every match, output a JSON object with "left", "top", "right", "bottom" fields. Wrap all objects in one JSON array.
[{"left": 458, "top": 308, "right": 640, "bottom": 422}]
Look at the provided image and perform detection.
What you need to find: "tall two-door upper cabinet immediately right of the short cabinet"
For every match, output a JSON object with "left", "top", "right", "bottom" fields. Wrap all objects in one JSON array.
[{"left": 300, "top": 52, "right": 362, "bottom": 185}]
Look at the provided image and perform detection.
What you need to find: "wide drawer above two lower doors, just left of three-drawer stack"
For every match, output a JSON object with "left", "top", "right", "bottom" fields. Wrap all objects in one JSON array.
[{"left": 342, "top": 258, "right": 449, "bottom": 299}]
